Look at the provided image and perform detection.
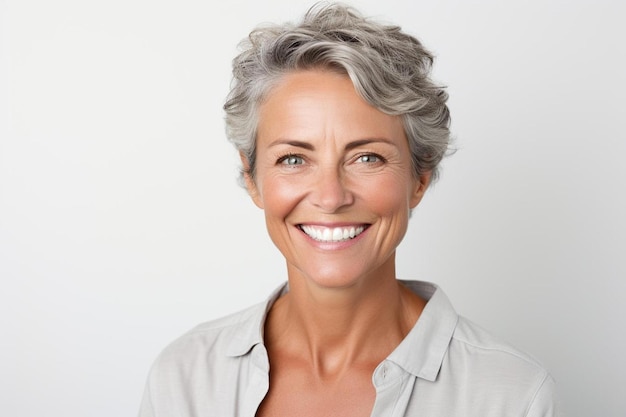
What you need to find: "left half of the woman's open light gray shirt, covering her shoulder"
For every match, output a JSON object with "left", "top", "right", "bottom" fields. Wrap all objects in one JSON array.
[{"left": 140, "top": 303, "right": 267, "bottom": 416}]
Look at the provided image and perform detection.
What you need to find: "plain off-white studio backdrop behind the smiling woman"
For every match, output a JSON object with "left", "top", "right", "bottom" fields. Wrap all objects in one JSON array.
[{"left": 0, "top": 0, "right": 626, "bottom": 417}]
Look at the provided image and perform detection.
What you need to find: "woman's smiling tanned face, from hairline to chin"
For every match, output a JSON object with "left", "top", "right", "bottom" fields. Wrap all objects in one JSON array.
[{"left": 243, "top": 70, "right": 429, "bottom": 287}]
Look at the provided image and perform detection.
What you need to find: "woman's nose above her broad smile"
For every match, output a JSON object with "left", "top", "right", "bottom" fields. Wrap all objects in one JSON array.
[{"left": 309, "top": 167, "right": 354, "bottom": 213}]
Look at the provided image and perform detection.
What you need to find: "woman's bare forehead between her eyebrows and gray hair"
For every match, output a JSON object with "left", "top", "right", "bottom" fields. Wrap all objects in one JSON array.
[{"left": 258, "top": 70, "right": 404, "bottom": 145}]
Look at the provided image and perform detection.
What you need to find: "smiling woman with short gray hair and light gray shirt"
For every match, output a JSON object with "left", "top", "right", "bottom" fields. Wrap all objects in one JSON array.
[{"left": 140, "top": 5, "right": 555, "bottom": 417}]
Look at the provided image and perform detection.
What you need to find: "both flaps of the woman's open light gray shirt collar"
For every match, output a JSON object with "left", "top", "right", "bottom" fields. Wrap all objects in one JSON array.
[{"left": 227, "top": 281, "right": 458, "bottom": 381}]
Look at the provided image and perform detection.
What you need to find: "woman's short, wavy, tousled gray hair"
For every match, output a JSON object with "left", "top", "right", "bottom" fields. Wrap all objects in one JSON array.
[{"left": 224, "top": 3, "right": 450, "bottom": 180}]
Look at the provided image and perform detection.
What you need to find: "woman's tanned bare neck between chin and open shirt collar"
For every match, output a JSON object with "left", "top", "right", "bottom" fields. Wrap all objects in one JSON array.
[{"left": 266, "top": 256, "right": 425, "bottom": 374}]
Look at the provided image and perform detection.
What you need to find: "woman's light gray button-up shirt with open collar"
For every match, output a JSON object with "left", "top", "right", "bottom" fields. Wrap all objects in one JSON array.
[{"left": 139, "top": 281, "right": 557, "bottom": 417}]
